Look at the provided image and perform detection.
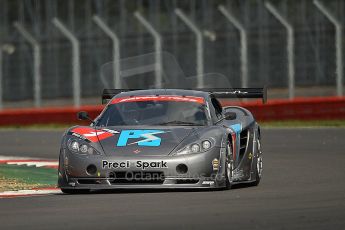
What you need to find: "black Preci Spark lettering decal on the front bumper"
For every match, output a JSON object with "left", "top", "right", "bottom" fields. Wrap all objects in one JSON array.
[{"left": 102, "top": 160, "right": 168, "bottom": 170}]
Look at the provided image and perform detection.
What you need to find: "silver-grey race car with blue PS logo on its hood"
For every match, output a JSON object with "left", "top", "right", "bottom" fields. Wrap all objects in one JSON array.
[{"left": 58, "top": 88, "right": 266, "bottom": 193}]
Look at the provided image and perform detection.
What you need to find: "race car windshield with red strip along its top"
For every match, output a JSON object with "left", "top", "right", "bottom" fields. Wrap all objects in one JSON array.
[{"left": 96, "top": 96, "right": 209, "bottom": 126}]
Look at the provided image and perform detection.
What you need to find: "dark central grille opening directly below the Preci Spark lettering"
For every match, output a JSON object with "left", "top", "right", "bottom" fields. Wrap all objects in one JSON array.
[{"left": 109, "top": 171, "right": 165, "bottom": 184}]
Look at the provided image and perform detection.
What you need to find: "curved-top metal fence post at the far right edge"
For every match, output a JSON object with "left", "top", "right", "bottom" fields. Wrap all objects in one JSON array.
[{"left": 314, "top": 0, "right": 344, "bottom": 96}]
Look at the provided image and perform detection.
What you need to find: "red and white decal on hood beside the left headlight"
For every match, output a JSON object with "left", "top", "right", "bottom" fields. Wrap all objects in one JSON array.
[{"left": 71, "top": 127, "right": 119, "bottom": 142}]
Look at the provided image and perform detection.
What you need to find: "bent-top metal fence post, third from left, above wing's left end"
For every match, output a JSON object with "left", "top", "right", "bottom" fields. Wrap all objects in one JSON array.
[{"left": 92, "top": 15, "right": 122, "bottom": 89}]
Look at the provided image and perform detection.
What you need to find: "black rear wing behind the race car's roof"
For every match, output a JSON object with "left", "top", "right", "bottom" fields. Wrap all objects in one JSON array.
[{"left": 102, "top": 87, "right": 267, "bottom": 104}]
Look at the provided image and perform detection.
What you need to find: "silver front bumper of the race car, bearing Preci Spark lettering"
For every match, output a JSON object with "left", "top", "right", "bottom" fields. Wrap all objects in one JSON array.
[{"left": 58, "top": 147, "right": 225, "bottom": 189}]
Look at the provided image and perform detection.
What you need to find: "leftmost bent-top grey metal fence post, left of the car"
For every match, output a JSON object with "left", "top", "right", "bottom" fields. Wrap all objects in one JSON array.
[{"left": 14, "top": 22, "right": 42, "bottom": 107}]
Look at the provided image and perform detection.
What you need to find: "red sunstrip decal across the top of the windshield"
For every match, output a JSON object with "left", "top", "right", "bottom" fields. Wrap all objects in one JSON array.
[{"left": 111, "top": 95, "right": 205, "bottom": 104}]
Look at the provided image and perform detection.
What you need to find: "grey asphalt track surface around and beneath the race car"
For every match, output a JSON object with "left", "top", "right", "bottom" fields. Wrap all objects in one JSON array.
[{"left": 0, "top": 128, "right": 345, "bottom": 230}]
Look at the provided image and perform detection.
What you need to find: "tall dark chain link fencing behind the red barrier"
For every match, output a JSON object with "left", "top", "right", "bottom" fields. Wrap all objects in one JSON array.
[{"left": 0, "top": 0, "right": 345, "bottom": 108}]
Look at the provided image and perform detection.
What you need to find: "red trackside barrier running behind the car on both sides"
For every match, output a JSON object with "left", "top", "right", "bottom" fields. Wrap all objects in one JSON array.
[{"left": 0, "top": 97, "right": 345, "bottom": 126}]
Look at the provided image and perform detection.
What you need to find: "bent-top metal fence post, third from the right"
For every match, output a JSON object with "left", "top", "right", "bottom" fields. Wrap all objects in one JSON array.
[{"left": 218, "top": 5, "right": 248, "bottom": 88}]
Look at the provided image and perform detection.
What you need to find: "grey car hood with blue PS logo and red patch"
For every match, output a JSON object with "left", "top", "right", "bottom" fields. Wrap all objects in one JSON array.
[{"left": 72, "top": 126, "right": 198, "bottom": 156}]
